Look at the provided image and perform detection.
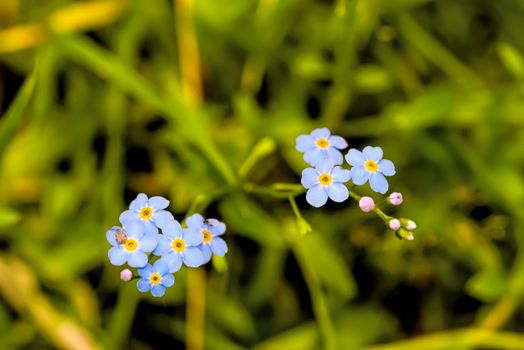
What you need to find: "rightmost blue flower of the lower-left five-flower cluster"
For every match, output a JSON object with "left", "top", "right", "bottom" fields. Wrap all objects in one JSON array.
[{"left": 186, "top": 214, "right": 227, "bottom": 264}]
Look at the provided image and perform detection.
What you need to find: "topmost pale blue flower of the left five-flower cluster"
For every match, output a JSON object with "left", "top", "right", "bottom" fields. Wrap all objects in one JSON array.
[{"left": 120, "top": 193, "right": 174, "bottom": 234}]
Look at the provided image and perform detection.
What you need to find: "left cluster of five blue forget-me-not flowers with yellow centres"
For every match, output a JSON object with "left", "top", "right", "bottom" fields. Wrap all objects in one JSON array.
[{"left": 106, "top": 193, "right": 227, "bottom": 297}]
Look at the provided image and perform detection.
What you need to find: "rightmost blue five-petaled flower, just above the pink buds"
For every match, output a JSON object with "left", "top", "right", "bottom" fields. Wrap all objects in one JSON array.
[{"left": 346, "top": 146, "right": 395, "bottom": 194}]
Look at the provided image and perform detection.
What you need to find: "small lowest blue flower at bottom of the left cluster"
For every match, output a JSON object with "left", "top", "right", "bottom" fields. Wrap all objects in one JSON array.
[{"left": 137, "top": 260, "right": 175, "bottom": 297}]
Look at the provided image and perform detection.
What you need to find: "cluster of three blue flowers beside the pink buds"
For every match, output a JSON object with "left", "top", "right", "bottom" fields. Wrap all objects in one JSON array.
[{"left": 296, "top": 128, "right": 395, "bottom": 207}]
